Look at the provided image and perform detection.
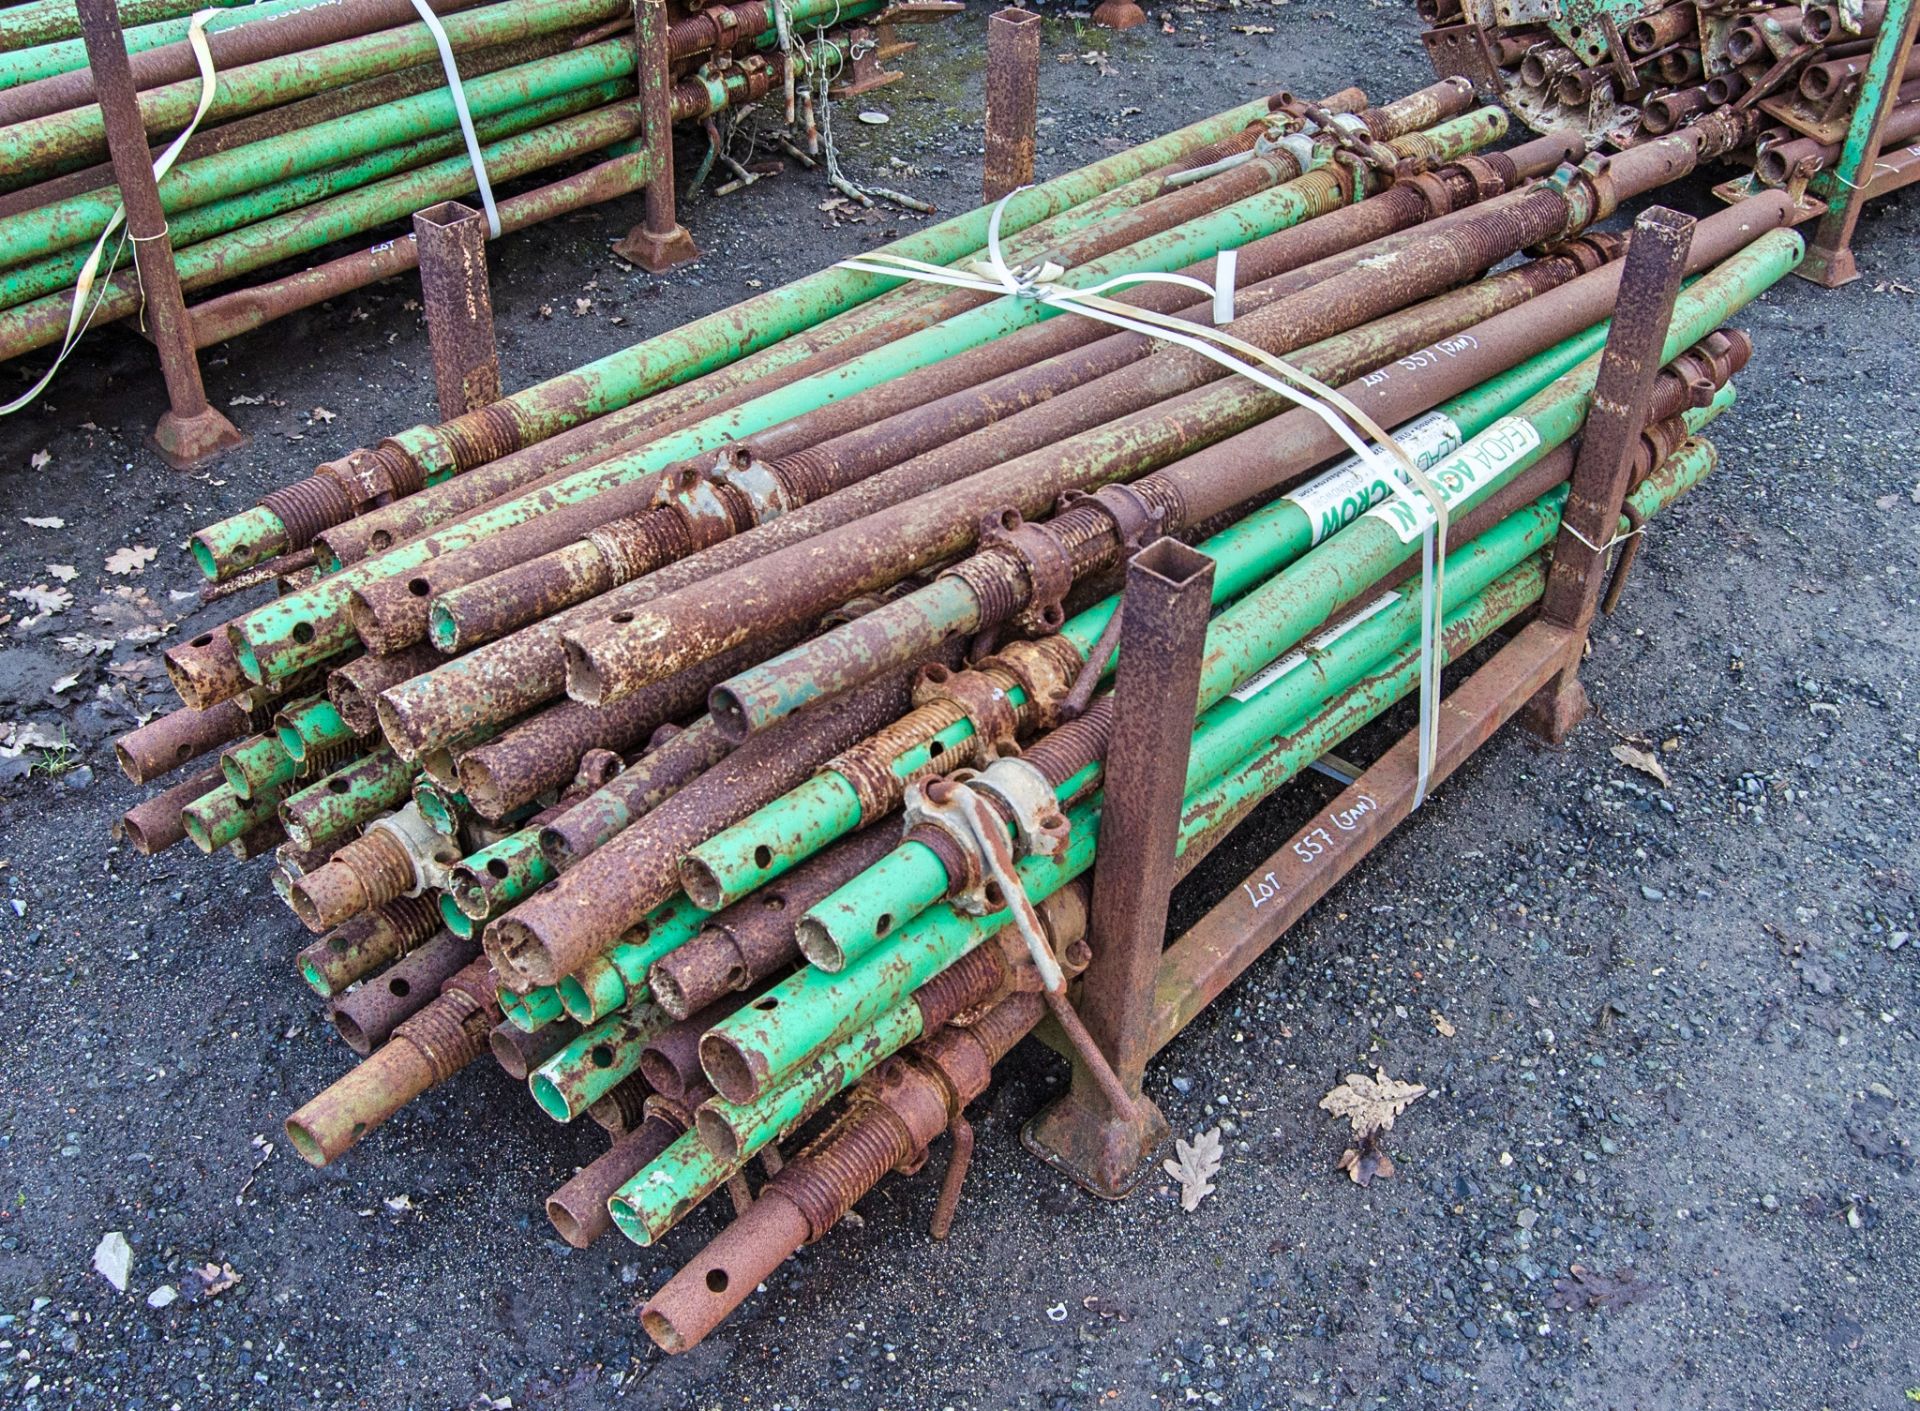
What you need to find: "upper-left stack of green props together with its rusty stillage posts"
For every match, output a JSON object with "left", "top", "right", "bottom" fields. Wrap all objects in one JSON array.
[{"left": 0, "top": 0, "right": 960, "bottom": 465}]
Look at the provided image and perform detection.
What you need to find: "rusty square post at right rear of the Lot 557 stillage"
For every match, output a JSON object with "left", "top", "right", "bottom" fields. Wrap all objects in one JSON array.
[{"left": 1524, "top": 205, "right": 1693, "bottom": 745}]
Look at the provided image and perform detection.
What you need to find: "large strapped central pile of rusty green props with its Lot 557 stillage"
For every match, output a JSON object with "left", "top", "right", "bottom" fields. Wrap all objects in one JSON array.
[{"left": 119, "top": 81, "right": 1801, "bottom": 1350}]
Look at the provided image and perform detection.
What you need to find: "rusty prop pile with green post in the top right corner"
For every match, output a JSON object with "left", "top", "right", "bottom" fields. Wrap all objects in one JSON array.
[{"left": 1421, "top": 0, "right": 1920, "bottom": 284}]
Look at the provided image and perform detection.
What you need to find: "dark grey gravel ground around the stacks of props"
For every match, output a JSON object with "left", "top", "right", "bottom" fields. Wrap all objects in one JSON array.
[{"left": 0, "top": 0, "right": 1920, "bottom": 1411}]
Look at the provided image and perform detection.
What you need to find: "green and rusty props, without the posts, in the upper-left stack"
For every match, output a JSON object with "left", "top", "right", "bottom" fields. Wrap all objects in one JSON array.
[{"left": 0, "top": 0, "right": 898, "bottom": 370}]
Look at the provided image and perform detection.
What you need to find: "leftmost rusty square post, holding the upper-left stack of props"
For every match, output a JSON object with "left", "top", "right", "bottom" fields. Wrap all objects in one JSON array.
[{"left": 79, "top": 0, "right": 246, "bottom": 470}]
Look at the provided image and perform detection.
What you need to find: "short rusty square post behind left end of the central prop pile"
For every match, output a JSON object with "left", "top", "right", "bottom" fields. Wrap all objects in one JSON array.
[{"left": 413, "top": 202, "right": 499, "bottom": 420}]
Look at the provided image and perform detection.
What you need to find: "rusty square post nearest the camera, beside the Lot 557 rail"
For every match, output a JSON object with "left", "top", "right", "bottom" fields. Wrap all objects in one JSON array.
[{"left": 1021, "top": 539, "right": 1213, "bottom": 1200}]
